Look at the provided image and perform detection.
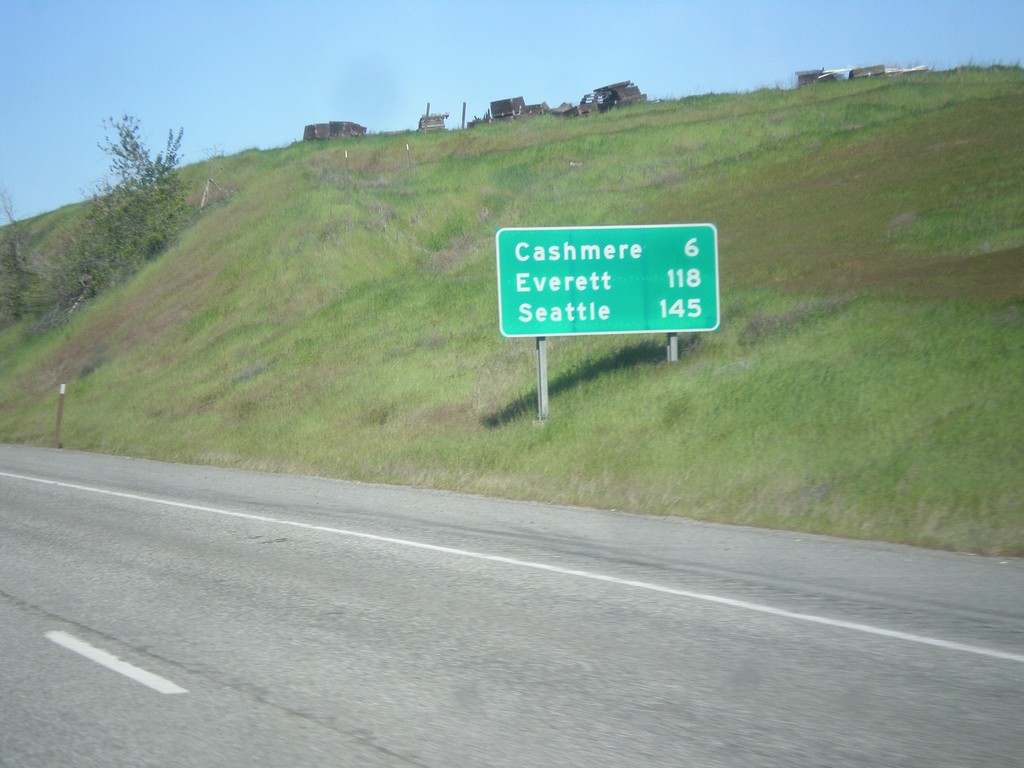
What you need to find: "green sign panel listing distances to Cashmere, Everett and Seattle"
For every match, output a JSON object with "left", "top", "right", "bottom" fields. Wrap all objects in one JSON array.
[{"left": 495, "top": 224, "right": 719, "bottom": 337}]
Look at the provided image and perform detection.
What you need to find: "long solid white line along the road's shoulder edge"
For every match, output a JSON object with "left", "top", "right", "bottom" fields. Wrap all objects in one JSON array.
[{"left": 0, "top": 472, "right": 1024, "bottom": 664}]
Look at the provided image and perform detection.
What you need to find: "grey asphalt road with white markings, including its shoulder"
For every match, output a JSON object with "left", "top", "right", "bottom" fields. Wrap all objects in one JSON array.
[{"left": 0, "top": 445, "right": 1024, "bottom": 768}]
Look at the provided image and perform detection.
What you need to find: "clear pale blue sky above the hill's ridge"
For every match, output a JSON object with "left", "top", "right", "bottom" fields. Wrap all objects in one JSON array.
[{"left": 0, "top": 0, "right": 1024, "bottom": 218}]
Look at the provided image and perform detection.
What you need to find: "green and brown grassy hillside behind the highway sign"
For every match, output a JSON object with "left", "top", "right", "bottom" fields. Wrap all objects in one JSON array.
[{"left": 0, "top": 68, "right": 1024, "bottom": 555}]
